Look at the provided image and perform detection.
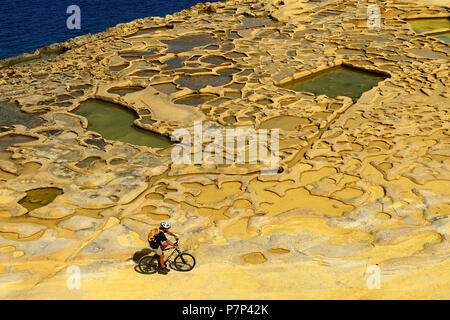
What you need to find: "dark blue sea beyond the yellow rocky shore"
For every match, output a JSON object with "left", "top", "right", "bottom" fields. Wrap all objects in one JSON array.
[{"left": 0, "top": 0, "right": 214, "bottom": 59}]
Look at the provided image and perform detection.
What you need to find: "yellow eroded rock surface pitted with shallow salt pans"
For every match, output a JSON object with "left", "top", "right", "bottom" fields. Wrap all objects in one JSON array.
[{"left": 0, "top": 0, "right": 450, "bottom": 299}]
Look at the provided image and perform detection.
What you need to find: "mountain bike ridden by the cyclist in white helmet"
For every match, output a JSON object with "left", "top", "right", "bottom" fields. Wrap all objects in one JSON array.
[{"left": 138, "top": 240, "right": 195, "bottom": 274}]
